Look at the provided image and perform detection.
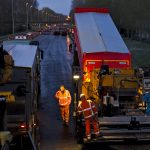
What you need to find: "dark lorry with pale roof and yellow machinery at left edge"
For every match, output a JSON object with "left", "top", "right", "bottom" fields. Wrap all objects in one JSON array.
[{"left": 0, "top": 41, "right": 42, "bottom": 150}]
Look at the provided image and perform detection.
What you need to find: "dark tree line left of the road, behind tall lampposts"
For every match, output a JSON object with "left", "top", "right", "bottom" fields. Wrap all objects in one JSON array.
[{"left": 0, "top": 0, "right": 65, "bottom": 36}]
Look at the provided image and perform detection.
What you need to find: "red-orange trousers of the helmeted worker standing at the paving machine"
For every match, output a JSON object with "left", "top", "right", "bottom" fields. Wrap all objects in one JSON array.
[{"left": 85, "top": 117, "right": 99, "bottom": 137}]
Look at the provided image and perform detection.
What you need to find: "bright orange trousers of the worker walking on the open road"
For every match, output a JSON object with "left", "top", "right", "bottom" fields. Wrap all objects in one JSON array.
[{"left": 60, "top": 105, "right": 69, "bottom": 123}]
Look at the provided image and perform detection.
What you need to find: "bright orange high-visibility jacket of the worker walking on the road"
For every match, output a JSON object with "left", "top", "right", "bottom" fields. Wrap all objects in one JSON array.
[{"left": 55, "top": 90, "right": 71, "bottom": 106}]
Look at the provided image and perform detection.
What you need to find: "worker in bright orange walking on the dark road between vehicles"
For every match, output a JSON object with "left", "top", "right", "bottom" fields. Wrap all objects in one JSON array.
[{"left": 55, "top": 85, "right": 71, "bottom": 126}]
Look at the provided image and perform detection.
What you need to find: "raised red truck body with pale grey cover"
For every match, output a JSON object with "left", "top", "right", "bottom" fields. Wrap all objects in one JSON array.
[{"left": 74, "top": 8, "right": 131, "bottom": 81}]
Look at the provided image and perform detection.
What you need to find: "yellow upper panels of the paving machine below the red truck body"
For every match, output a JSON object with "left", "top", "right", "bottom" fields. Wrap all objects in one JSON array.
[{"left": 82, "top": 69, "right": 139, "bottom": 102}]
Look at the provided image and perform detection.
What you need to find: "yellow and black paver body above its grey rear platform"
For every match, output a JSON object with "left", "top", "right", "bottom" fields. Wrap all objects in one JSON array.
[{"left": 79, "top": 65, "right": 149, "bottom": 116}]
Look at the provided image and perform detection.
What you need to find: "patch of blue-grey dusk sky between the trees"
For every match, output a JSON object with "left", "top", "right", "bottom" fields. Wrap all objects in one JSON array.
[{"left": 38, "top": 0, "right": 72, "bottom": 15}]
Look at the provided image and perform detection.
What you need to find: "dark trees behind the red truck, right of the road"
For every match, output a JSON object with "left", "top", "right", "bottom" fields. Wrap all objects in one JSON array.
[{"left": 70, "top": 0, "right": 150, "bottom": 41}]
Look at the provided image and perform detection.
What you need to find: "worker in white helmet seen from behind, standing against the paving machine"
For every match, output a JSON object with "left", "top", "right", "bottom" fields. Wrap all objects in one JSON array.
[{"left": 78, "top": 94, "right": 99, "bottom": 140}]
